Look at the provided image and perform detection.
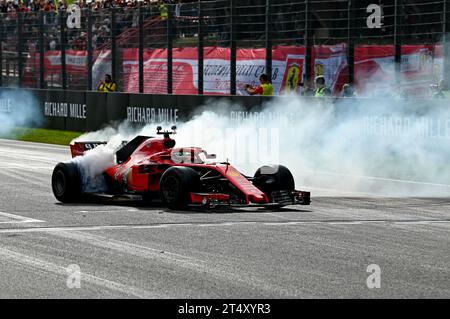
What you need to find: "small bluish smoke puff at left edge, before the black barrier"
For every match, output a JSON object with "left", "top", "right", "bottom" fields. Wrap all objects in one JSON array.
[{"left": 0, "top": 89, "right": 43, "bottom": 136}]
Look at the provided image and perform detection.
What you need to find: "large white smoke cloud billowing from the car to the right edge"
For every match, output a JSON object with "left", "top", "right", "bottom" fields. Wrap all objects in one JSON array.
[{"left": 71, "top": 92, "right": 450, "bottom": 196}]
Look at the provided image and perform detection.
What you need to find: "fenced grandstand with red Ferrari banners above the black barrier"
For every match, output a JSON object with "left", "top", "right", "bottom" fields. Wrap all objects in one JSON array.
[{"left": 0, "top": 0, "right": 450, "bottom": 95}]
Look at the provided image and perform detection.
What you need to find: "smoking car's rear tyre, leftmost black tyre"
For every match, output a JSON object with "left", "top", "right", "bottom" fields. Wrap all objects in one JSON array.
[{"left": 52, "top": 162, "right": 81, "bottom": 203}]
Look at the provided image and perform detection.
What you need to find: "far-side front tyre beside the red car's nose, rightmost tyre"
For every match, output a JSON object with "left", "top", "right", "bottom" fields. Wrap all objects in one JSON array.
[{"left": 253, "top": 165, "right": 295, "bottom": 202}]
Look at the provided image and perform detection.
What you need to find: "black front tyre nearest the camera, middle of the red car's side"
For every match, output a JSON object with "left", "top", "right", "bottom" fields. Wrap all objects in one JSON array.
[{"left": 160, "top": 166, "right": 200, "bottom": 209}]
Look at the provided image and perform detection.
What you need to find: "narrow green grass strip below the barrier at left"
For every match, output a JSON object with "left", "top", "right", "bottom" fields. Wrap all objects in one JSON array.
[{"left": 0, "top": 127, "right": 83, "bottom": 145}]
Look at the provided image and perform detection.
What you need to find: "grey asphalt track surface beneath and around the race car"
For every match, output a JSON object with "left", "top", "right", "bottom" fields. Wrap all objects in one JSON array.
[{"left": 0, "top": 140, "right": 450, "bottom": 298}]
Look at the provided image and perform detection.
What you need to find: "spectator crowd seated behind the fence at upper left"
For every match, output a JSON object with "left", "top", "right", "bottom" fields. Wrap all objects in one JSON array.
[{"left": 0, "top": 0, "right": 192, "bottom": 52}]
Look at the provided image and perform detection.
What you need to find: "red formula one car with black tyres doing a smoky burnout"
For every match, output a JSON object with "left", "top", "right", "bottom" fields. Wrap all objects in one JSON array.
[{"left": 52, "top": 127, "right": 310, "bottom": 209}]
